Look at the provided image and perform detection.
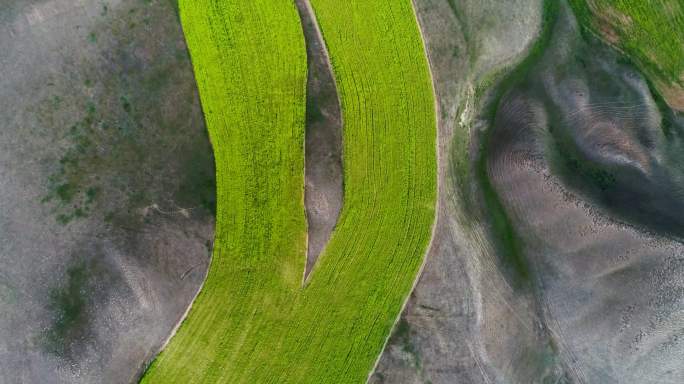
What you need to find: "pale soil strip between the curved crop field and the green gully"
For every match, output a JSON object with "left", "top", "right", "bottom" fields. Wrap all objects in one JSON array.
[{"left": 369, "top": 0, "right": 557, "bottom": 384}]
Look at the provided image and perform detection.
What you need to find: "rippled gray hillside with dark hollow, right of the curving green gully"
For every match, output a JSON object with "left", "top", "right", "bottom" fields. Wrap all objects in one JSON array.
[{"left": 488, "top": 2, "right": 684, "bottom": 384}]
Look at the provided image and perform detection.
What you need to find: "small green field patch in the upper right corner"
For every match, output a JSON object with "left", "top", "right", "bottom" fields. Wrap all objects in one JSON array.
[{"left": 571, "top": 0, "right": 684, "bottom": 110}]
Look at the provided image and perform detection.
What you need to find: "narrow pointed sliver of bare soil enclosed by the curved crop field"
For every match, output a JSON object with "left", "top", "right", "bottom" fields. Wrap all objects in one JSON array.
[{"left": 295, "top": 0, "right": 344, "bottom": 274}]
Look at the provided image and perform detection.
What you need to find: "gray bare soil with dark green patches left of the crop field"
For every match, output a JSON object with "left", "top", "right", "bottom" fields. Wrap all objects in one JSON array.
[{"left": 0, "top": 0, "right": 215, "bottom": 384}]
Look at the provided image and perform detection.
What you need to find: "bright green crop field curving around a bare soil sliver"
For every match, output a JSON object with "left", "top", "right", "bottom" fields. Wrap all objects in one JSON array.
[{"left": 142, "top": 0, "right": 436, "bottom": 384}]
